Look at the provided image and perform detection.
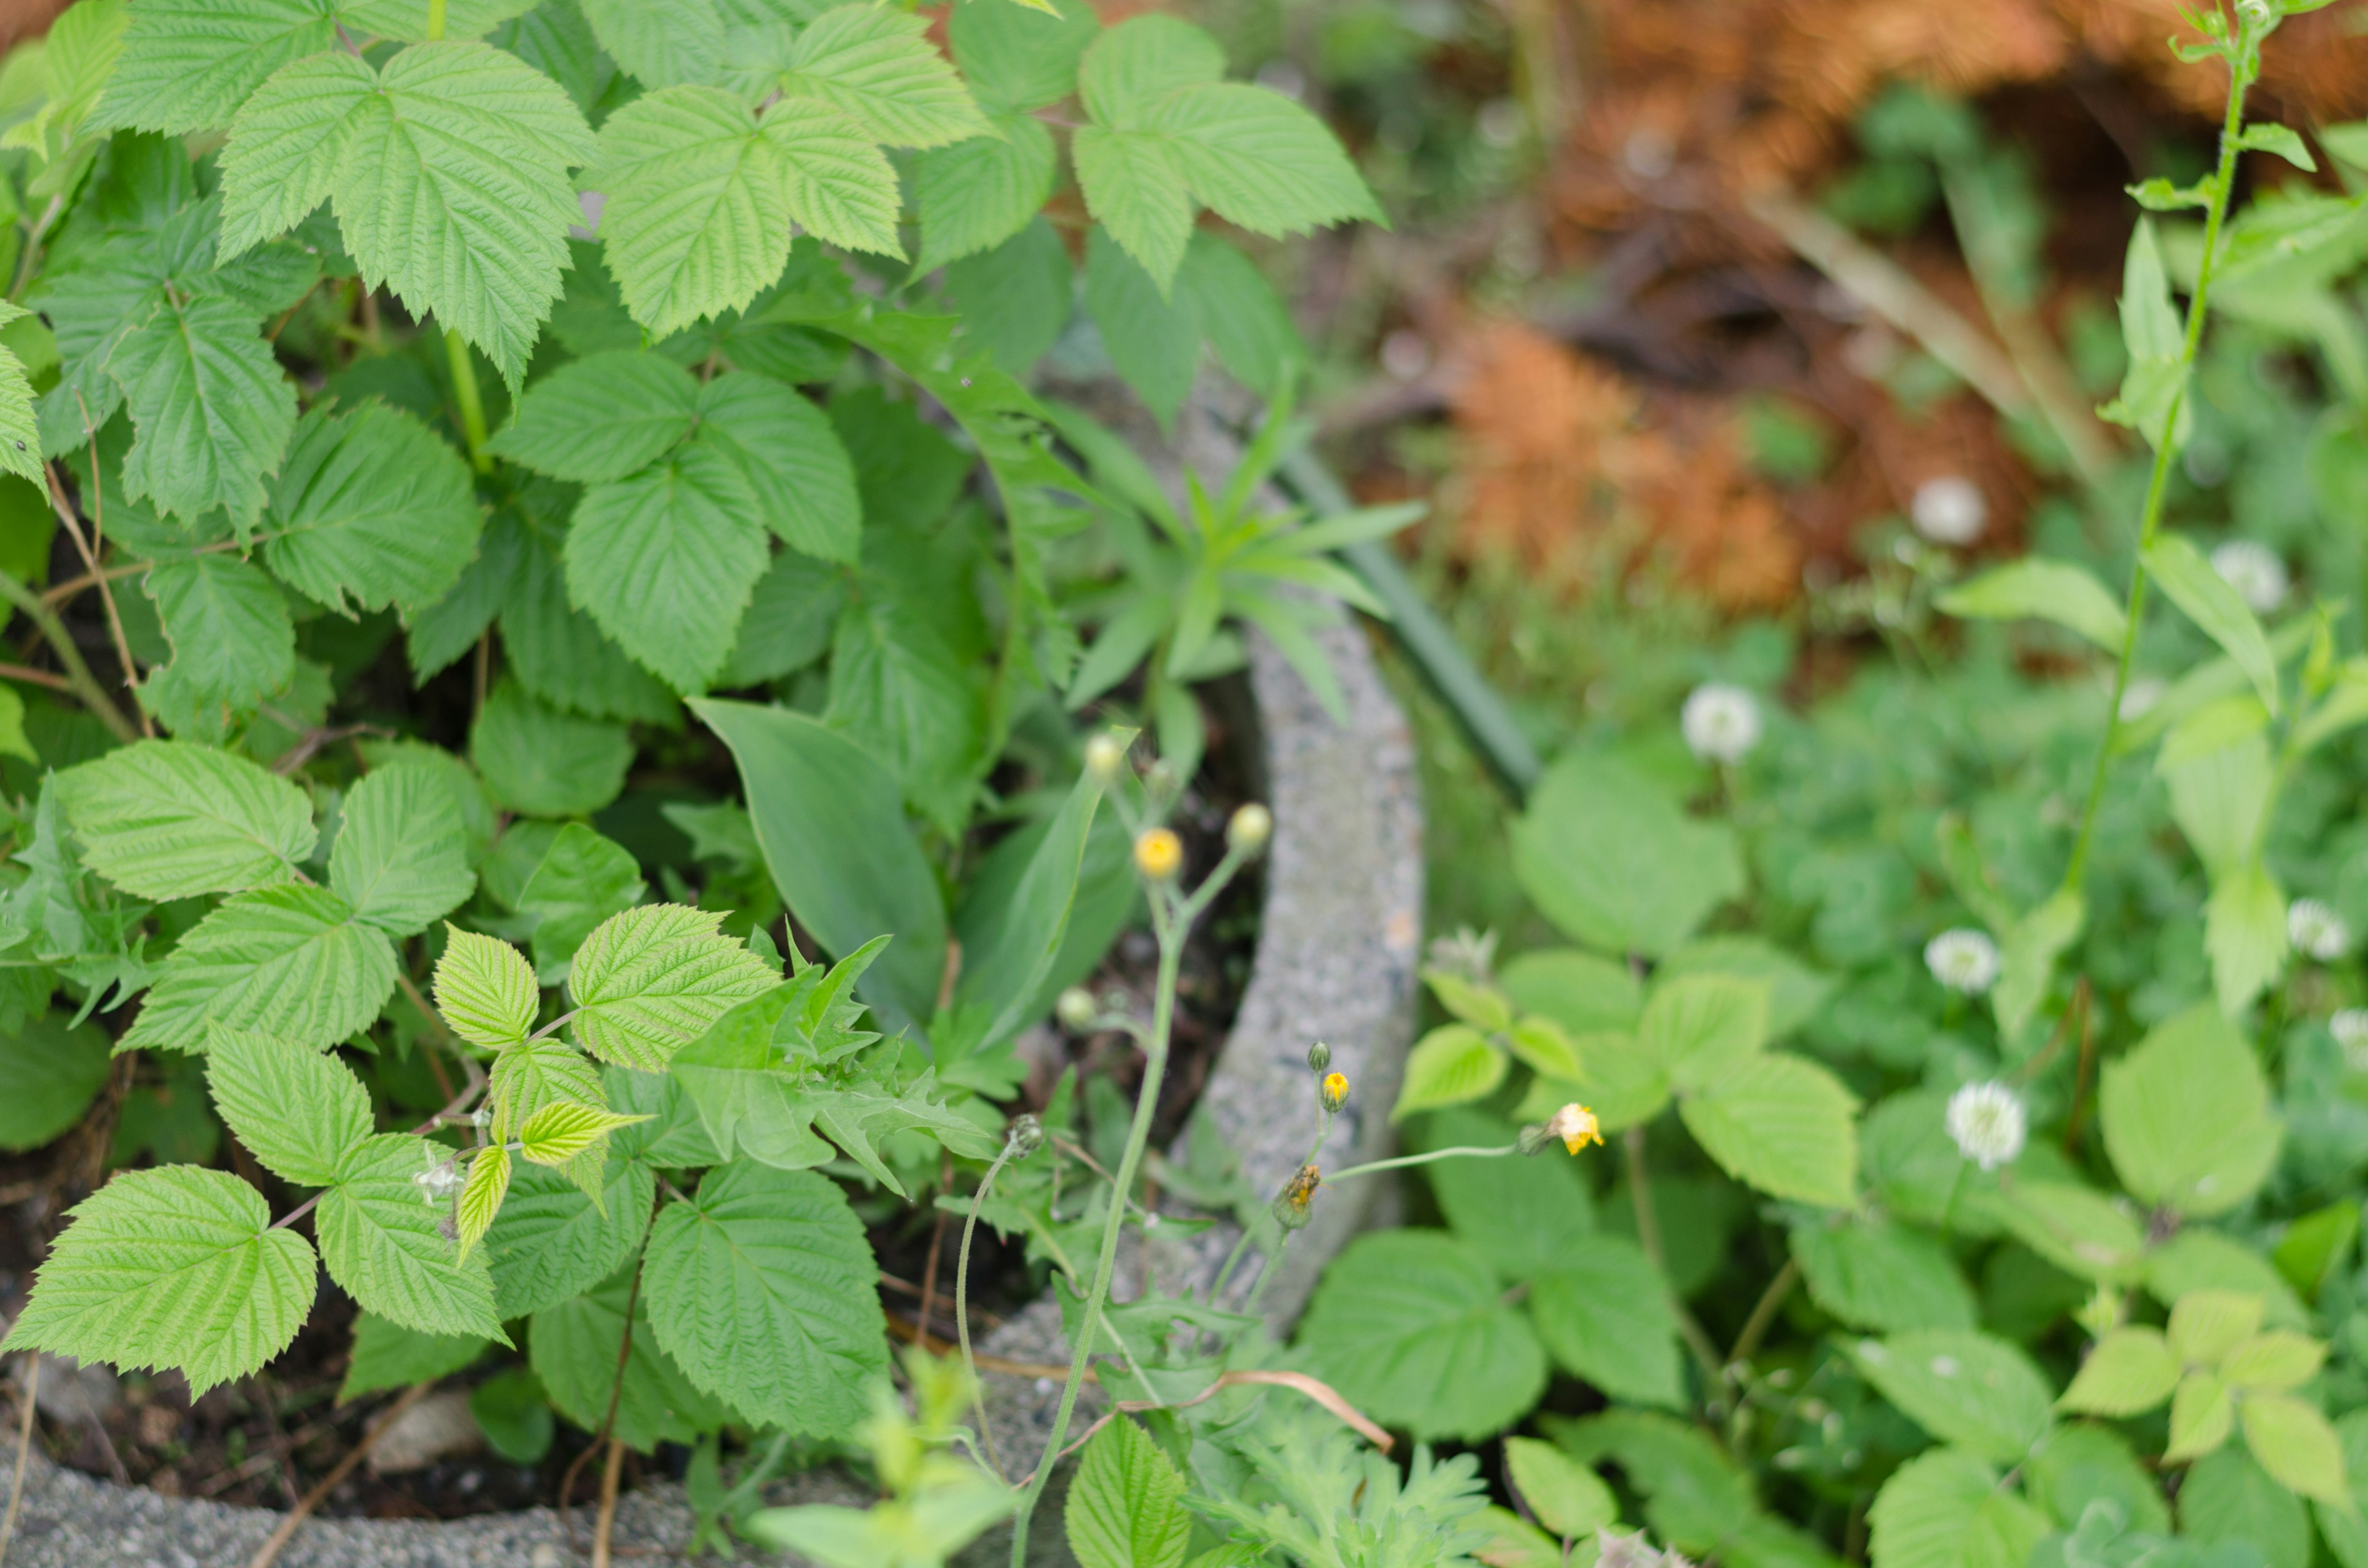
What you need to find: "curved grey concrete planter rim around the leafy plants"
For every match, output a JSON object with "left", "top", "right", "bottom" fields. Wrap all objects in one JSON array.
[{"left": 0, "top": 414, "right": 1423, "bottom": 1568}]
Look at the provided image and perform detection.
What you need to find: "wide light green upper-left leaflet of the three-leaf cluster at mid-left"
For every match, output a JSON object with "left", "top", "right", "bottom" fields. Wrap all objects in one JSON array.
[{"left": 57, "top": 741, "right": 315, "bottom": 898}]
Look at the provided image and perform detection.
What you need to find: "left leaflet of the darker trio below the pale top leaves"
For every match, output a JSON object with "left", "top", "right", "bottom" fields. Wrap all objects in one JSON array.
[{"left": 493, "top": 348, "right": 699, "bottom": 485}]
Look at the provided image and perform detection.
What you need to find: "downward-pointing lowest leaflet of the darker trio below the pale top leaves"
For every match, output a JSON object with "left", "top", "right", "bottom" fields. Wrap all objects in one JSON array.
[{"left": 566, "top": 438, "right": 767, "bottom": 692}]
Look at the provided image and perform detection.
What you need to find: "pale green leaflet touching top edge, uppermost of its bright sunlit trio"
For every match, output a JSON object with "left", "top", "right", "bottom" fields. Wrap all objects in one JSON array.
[{"left": 781, "top": 5, "right": 987, "bottom": 147}]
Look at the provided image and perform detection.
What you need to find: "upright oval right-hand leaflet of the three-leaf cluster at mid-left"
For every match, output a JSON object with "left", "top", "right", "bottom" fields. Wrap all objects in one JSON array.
[{"left": 329, "top": 763, "right": 476, "bottom": 938}]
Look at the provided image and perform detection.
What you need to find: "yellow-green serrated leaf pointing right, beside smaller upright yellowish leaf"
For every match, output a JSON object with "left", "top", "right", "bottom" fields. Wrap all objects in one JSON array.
[{"left": 569, "top": 905, "right": 781, "bottom": 1073}]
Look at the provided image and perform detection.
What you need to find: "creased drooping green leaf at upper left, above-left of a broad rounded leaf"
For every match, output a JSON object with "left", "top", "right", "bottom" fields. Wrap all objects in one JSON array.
[{"left": 107, "top": 293, "right": 296, "bottom": 528}]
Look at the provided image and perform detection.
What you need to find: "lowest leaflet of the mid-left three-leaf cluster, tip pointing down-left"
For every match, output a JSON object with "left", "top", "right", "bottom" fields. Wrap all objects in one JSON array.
[{"left": 118, "top": 886, "right": 395, "bottom": 1052}]
